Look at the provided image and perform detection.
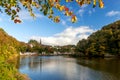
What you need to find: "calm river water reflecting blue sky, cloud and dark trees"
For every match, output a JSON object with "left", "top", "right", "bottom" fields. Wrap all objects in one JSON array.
[{"left": 19, "top": 56, "right": 120, "bottom": 80}]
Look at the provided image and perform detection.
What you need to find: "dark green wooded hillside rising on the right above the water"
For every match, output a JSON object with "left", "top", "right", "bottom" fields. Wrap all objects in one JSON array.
[{"left": 76, "top": 20, "right": 120, "bottom": 57}]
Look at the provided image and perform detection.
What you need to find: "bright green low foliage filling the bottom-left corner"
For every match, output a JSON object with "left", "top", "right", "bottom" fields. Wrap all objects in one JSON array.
[{"left": 0, "top": 56, "right": 28, "bottom": 80}]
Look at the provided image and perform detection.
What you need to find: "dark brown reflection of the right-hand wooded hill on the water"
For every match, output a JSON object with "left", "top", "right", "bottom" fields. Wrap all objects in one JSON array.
[{"left": 77, "top": 58, "right": 120, "bottom": 79}]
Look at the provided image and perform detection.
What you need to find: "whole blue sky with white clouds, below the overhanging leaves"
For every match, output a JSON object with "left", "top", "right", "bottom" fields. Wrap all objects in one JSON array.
[{"left": 0, "top": 0, "right": 120, "bottom": 46}]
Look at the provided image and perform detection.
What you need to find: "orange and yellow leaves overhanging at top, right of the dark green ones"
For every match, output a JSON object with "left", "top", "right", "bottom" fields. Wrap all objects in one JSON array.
[{"left": 21, "top": 0, "right": 104, "bottom": 23}]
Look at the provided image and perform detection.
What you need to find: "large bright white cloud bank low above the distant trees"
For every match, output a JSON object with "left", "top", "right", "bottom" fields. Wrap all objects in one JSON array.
[{"left": 30, "top": 26, "right": 95, "bottom": 46}]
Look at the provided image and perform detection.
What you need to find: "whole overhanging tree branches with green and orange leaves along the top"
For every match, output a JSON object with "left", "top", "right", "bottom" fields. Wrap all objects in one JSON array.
[{"left": 0, "top": 0, "right": 104, "bottom": 23}]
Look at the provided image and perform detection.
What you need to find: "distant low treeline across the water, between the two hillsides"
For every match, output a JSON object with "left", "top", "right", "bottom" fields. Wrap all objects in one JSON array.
[{"left": 20, "top": 39, "right": 75, "bottom": 55}]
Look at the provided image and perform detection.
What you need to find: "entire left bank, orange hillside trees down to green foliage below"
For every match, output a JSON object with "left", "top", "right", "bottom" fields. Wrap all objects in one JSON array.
[{"left": 0, "top": 28, "right": 27, "bottom": 80}]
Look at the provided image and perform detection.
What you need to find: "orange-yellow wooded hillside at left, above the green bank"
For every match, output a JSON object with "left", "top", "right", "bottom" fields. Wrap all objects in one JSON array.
[{"left": 0, "top": 28, "right": 19, "bottom": 59}]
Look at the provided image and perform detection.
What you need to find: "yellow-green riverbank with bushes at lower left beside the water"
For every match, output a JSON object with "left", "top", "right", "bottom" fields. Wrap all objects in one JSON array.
[{"left": 0, "top": 54, "right": 30, "bottom": 80}]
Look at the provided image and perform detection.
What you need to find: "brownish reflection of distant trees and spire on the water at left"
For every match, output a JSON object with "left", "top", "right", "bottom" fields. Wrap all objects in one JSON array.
[{"left": 20, "top": 56, "right": 51, "bottom": 70}]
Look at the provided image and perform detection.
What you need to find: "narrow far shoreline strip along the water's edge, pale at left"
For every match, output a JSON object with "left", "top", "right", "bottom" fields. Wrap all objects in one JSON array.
[{"left": 20, "top": 52, "right": 120, "bottom": 58}]
